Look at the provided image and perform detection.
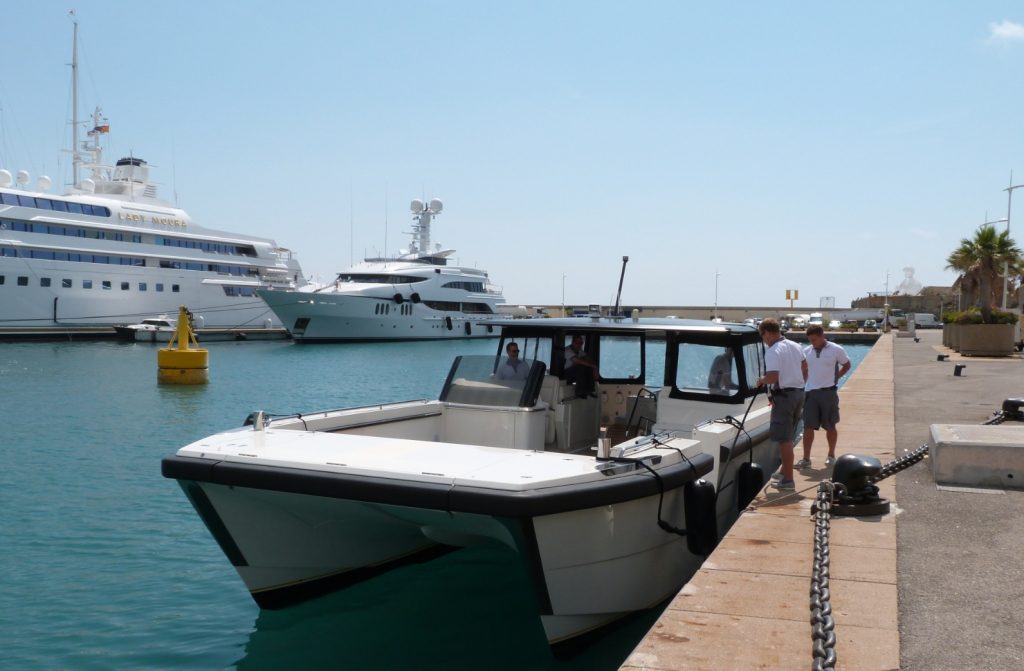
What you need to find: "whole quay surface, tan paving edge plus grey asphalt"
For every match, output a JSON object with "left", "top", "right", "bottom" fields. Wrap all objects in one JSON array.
[{"left": 623, "top": 333, "right": 1024, "bottom": 671}]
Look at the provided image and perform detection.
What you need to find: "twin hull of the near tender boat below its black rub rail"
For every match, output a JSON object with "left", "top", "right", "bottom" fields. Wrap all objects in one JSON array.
[{"left": 164, "top": 457, "right": 710, "bottom": 643}]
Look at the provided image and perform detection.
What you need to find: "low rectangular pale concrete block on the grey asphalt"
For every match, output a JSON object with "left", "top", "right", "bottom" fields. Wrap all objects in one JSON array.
[{"left": 929, "top": 424, "right": 1024, "bottom": 490}]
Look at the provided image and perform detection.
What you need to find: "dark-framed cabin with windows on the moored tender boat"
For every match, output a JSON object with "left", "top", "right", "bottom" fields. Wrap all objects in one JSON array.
[{"left": 483, "top": 318, "right": 764, "bottom": 452}]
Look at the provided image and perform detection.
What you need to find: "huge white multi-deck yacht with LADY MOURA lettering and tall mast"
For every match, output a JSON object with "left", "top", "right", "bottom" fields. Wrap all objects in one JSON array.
[{"left": 0, "top": 23, "right": 304, "bottom": 334}]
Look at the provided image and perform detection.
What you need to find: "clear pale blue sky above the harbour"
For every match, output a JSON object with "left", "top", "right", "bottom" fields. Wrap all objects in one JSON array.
[{"left": 0, "top": 0, "right": 1024, "bottom": 307}]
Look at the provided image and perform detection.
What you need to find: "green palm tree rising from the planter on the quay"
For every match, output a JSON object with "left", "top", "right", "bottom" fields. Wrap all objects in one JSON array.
[{"left": 946, "top": 225, "right": 1024, "bottom": 324}]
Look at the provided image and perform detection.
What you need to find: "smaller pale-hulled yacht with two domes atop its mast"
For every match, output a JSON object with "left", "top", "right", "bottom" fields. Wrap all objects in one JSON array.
[{"left": 258, "top": 198, "right": 505, "bottom": 342}]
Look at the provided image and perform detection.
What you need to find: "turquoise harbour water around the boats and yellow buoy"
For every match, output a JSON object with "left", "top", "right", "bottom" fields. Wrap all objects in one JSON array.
[{"left": 0, "top": 341, "right": 868, "bottom": 670}]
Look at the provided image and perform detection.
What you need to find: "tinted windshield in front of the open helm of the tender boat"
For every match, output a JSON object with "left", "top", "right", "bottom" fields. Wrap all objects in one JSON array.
[{"left": 440, "top": 354, "right": 546, "bottom": 408}]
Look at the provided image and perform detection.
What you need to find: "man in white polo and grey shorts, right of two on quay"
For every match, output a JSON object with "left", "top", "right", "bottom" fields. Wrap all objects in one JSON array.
[{"left": 797, "top": 324, "right": 850, "bottom": 468}]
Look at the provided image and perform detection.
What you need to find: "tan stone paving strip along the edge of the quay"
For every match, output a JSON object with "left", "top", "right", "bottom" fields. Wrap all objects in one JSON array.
[{"left": 622, "top": 337, "right": 897, "bottom": 671}]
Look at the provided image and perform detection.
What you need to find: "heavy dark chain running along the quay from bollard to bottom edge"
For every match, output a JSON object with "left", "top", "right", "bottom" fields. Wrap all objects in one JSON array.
[{"left": 811, "top": 481, "right": 836, "bottom": 671}]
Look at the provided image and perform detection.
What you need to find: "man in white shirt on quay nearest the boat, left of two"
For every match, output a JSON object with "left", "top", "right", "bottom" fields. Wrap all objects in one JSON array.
[{"left": 758, "top": 319, "right": 807, "bottom": 492}]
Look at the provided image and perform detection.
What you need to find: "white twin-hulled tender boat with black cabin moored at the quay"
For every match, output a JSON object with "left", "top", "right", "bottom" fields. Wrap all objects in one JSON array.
[{"left": 163, "top": 319, "right": 778, "bottom": 643}]
